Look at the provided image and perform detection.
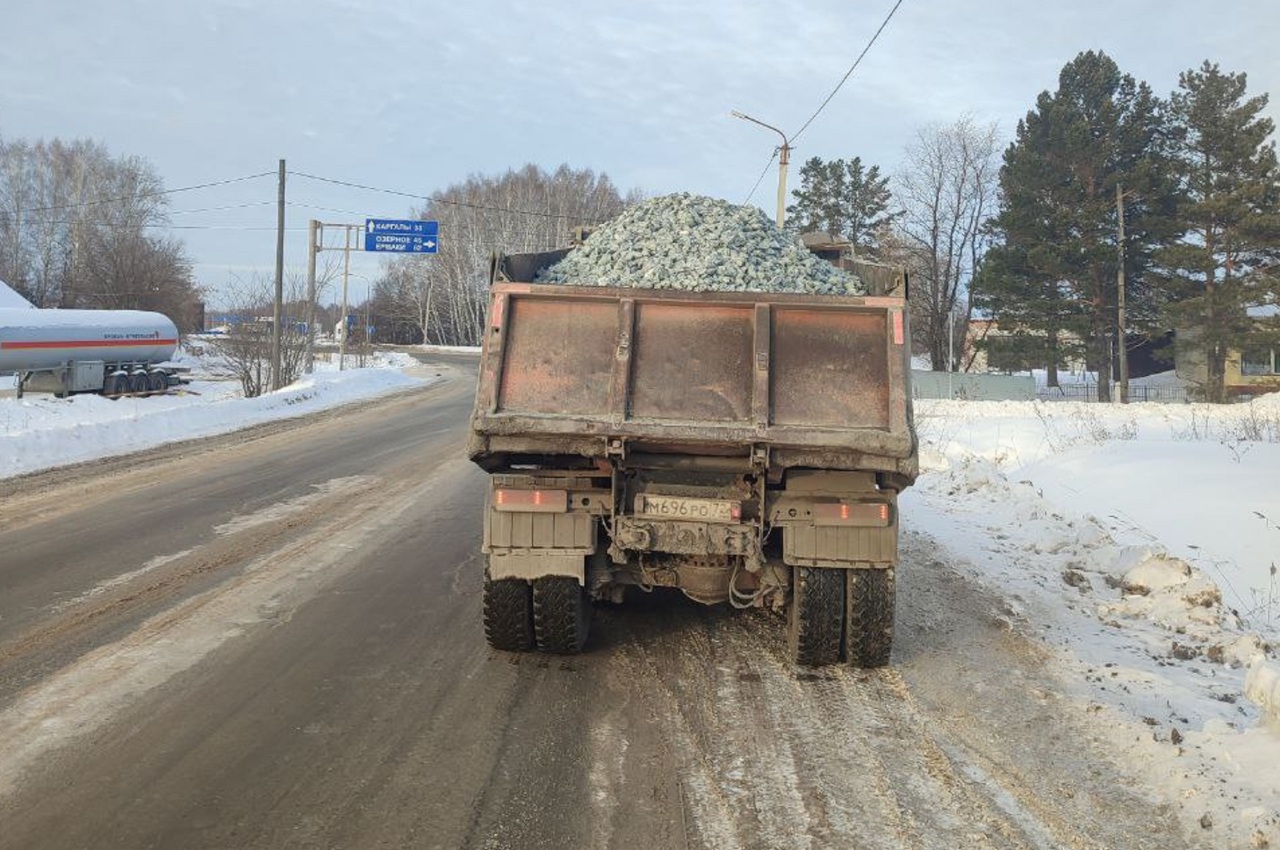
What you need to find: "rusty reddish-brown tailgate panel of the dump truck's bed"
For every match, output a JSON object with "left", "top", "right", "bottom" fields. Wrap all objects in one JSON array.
[{"left": 468, "top": 282, "right": 916, "bottom": 483}]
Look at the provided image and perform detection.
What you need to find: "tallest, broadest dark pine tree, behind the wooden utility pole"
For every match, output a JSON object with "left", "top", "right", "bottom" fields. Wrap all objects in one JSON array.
[{"left": 975, "top": 51, "right": 1171, "bottom": 401}]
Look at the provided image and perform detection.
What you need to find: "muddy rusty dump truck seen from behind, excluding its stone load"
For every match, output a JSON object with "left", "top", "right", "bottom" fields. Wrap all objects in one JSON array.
[{"left": 467, "top": 241, "right": 918, "bottom": 667}]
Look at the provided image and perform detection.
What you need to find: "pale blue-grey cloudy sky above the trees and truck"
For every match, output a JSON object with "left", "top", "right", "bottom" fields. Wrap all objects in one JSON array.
[{"left": 0, "top": 0, "right": 1280, "bottom": 308}]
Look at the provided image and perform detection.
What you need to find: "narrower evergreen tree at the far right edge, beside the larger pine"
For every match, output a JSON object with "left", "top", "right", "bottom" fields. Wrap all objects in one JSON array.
[{"left": 1158, "top": 61, "right": 1280, "bottom": 402}]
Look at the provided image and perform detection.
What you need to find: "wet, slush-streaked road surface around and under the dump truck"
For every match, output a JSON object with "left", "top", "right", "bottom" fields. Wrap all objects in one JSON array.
[{"left": 0, "top": 355, "right": 1184, "bottom": 850}]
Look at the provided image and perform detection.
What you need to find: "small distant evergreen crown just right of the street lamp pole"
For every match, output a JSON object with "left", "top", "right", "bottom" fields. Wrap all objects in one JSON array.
[{"left": 787, "top": 156, "right": 893, "bottom": 255}]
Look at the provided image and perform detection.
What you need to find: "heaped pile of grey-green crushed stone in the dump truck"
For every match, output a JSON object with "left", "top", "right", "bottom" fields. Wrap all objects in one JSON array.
[{"left": 535, "top": 192, "right": 867, "bottom": 296}]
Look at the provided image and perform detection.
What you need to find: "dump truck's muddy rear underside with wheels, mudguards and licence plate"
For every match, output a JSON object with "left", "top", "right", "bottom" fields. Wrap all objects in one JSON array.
[{"left": 484, "top": 458, "right": 897, "bottom": 667}]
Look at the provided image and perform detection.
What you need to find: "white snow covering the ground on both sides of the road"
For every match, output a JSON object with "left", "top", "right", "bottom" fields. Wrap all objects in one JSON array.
[{"left": 0, "top": 356, "right": 1280, "bottom": 847}]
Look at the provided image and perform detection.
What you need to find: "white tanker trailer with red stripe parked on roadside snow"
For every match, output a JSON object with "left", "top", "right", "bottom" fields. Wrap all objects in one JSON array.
[{"left": 0, "top": 309, "right": 185, "bottom": 398}]
